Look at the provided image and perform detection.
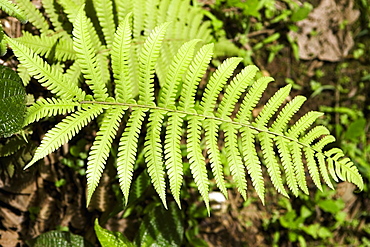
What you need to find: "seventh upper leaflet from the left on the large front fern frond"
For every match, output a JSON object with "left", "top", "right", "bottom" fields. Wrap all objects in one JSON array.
[{"left": 200, "top": 57, "right": 243, "bottom": 115}]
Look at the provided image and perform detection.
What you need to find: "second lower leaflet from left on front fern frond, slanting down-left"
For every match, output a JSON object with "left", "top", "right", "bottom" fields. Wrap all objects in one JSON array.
[{"left": 24, "top": 105, "right": 103, "bottom": 169}]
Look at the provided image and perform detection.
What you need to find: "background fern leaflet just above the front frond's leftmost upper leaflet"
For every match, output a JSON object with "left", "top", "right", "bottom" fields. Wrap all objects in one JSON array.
[{"left": 15, "top": 32, "right": 76, "bottom": 61}]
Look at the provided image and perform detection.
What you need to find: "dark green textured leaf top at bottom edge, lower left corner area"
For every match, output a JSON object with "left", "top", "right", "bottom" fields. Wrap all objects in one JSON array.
[{"left": 27, "top": 231, "right": 94, "bottom": 247}]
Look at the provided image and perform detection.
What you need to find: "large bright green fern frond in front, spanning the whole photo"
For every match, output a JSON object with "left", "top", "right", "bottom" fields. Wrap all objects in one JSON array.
[{"left": 6, "top": 1, "right": 363, "bottom": 214}]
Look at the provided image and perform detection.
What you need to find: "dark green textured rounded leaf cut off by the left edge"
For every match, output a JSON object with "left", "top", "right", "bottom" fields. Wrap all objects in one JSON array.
[{"left": 0, "top": 66, "right": 26, "bottom": 138}]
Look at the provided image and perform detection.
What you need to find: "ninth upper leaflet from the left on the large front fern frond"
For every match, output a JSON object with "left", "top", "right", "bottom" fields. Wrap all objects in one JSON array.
[{"left": 236, "top": 77, "right": 274, "bottom": 123}]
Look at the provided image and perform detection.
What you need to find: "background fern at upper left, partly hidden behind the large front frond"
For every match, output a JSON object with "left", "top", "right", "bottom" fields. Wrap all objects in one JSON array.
[{"left": 10, "top": 0, "right": 212, "bottom": 91}]
